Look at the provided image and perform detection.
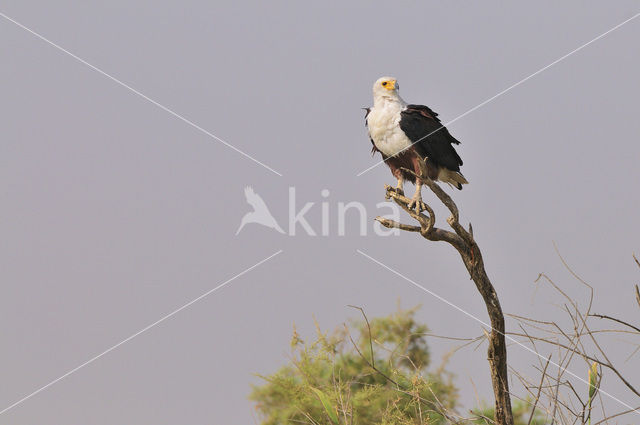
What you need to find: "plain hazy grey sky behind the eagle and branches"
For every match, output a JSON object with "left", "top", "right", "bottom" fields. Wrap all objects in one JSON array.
[{"left": 0, "top": 0, "right": 640, "bottom": 425}]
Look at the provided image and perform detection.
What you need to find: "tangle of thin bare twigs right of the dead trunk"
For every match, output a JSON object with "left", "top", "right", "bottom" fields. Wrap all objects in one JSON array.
[{"left": 509, "top": 252, "right": 640, "bottom": 425}]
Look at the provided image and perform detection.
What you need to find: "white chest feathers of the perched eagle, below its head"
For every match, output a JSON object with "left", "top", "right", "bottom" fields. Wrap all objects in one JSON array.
[{"left": 367, "top": 103, "right": 411, "bottom": 156}]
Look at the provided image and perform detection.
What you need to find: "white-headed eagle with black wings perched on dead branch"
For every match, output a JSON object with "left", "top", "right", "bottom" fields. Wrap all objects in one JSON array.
[{"left": 365, "top": 77, "right": 469, "bottom": 211}]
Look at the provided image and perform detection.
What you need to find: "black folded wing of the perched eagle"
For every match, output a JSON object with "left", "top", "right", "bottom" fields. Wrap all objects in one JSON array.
[{"left": 400, "top": 105, "right": 462, "bottom": 171}]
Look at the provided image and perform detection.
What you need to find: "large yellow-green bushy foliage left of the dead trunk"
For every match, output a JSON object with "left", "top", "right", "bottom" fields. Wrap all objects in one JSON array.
[{"left": 250, "top": 309, "right": 457, "bottom": 425}]
